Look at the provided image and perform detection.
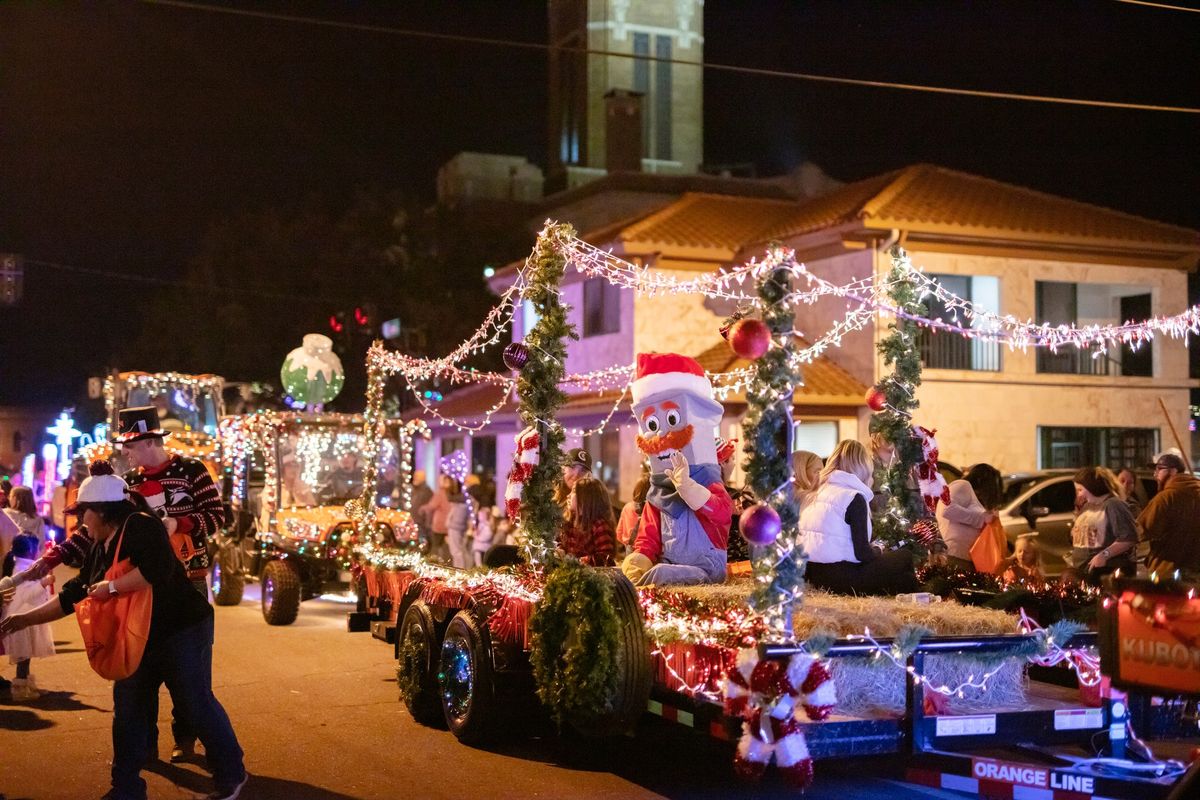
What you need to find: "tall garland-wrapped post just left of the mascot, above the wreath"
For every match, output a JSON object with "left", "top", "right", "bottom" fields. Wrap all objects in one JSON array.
[{"left": 517, "top": 223, "right": 578, "bottom": 564}]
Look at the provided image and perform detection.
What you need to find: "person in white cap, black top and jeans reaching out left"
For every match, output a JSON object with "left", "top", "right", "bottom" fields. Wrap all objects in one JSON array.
[{"left": 0, "top": 464, "right": 247, "bottom": 800}]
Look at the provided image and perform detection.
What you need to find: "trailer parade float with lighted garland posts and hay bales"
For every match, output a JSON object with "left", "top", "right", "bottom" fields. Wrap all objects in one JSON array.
[{"left": 352, "top": 223, "right": 1200, "bottom": 799}]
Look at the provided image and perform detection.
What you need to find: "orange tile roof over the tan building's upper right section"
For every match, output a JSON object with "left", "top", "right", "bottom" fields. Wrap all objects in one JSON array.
[{"left": 748, "top": 164, "right": 1200, "bottom": 251}]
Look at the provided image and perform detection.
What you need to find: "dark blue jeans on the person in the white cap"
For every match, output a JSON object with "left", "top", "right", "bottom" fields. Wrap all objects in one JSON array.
[{"left": 113, "top": 616, "right": 246, "bottom": 800}]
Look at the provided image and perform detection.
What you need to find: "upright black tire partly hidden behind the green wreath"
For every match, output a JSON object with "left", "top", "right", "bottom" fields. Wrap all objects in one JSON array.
[{"left": 569, "top": 569, "right": 653, "bottom": 736}]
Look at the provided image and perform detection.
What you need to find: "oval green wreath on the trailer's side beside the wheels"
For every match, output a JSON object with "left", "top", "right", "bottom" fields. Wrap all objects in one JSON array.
[{"left": 529, "top": 559, "right": 620, "bottom": 726}]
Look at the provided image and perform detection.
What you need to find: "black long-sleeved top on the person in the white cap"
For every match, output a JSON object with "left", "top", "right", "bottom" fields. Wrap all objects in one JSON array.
[{"left": 59, "top": 513, "right": 212, "bottom": 645}]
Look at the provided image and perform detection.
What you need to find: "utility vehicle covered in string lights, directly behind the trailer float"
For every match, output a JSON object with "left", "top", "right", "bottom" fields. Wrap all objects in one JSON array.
[{"left": 212, "top": 411, "right": 416, "bottom": 625}]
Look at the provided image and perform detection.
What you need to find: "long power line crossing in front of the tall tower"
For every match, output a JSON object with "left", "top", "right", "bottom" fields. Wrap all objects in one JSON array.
[{"left": 139, "top": 0, "right": 1200, "bottom": 114}]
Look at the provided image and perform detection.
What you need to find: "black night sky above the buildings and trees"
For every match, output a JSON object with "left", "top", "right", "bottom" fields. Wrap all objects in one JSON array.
[{"left": 0, "top": 0, "right": 1200, "bottom": 405}]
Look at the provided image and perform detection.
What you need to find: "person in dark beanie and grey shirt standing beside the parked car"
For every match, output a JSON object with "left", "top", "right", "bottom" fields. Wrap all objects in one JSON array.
[{"left": 1070, "top": 467, "right": 1138, "bottom": 583}]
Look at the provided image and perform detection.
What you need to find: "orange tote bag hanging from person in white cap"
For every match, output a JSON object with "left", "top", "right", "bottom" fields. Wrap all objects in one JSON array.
[{"left": 76, "top": 519, "right": 154, "bottom": 680}]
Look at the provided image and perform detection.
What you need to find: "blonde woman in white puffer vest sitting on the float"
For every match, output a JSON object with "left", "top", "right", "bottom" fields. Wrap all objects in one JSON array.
[{"left": 799, "top": 439, "right": 919, "bottom": 595}]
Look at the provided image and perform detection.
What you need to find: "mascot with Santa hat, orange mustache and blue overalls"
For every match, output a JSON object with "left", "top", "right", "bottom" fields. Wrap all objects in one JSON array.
[{"left": 622, "top": 353, "right": 733, "bottom": 585}]
